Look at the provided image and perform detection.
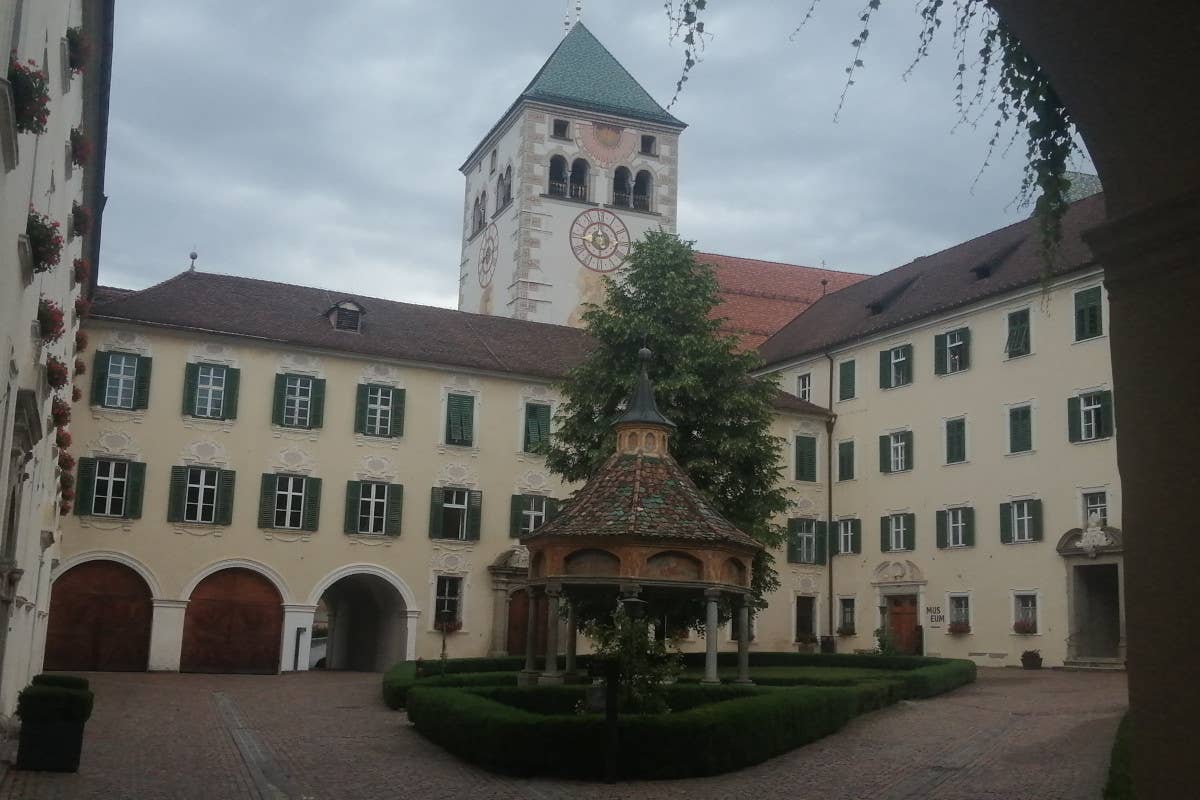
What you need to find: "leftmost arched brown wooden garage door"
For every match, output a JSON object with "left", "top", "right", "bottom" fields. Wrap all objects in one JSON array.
[{"left": 46, "top": 561, "right": 154, "bottom": 672}]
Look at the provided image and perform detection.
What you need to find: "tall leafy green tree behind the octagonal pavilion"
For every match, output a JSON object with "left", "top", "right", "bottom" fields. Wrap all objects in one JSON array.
[{"left": 547, "top": 231, "right": 788, "bottom": 618}]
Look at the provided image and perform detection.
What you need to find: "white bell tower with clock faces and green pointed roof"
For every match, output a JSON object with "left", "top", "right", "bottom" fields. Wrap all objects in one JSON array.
[{"left": 458, "top": 22, "right": 685, "bottom": 326}]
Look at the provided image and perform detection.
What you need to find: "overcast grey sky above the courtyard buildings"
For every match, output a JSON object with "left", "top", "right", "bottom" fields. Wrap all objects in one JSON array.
[{"left": 100, "top": 0, "right": 1091, "bottom": 307}]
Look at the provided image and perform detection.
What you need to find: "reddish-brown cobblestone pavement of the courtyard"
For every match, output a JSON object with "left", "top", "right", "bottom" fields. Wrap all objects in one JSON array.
[{"left": 0, "top": 669, "right": 1127, "bottom": 800}]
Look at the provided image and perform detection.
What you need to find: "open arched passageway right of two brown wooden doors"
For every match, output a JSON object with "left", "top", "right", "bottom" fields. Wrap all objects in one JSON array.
[{"left": 311, "top": 573, "right": 408, "bottom": 672}]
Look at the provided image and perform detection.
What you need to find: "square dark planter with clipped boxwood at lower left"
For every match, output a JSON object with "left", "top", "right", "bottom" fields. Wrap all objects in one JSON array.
[{"left": 17, "top": 671, "right": 94, "bottom": 772}]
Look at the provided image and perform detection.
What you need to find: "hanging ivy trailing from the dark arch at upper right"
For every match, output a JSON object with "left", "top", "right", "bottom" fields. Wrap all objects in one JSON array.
[{"left": 664, "top": 0, "right": 1075, "bottom": 262}]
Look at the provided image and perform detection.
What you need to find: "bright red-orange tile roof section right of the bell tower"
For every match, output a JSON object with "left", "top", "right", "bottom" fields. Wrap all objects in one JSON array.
[{"left": 696, "top": 253, "right": 868, "bottom": 349}]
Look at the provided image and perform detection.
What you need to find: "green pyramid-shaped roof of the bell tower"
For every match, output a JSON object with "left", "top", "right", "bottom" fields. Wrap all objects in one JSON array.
[{"left": 521, "top": 23, "right": 684, "bottom": 128}]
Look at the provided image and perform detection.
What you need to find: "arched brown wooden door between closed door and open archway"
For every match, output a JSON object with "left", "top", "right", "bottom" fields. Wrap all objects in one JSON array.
[{"left": 180, "top": 569, "right": 283, "bottom": 674}]
